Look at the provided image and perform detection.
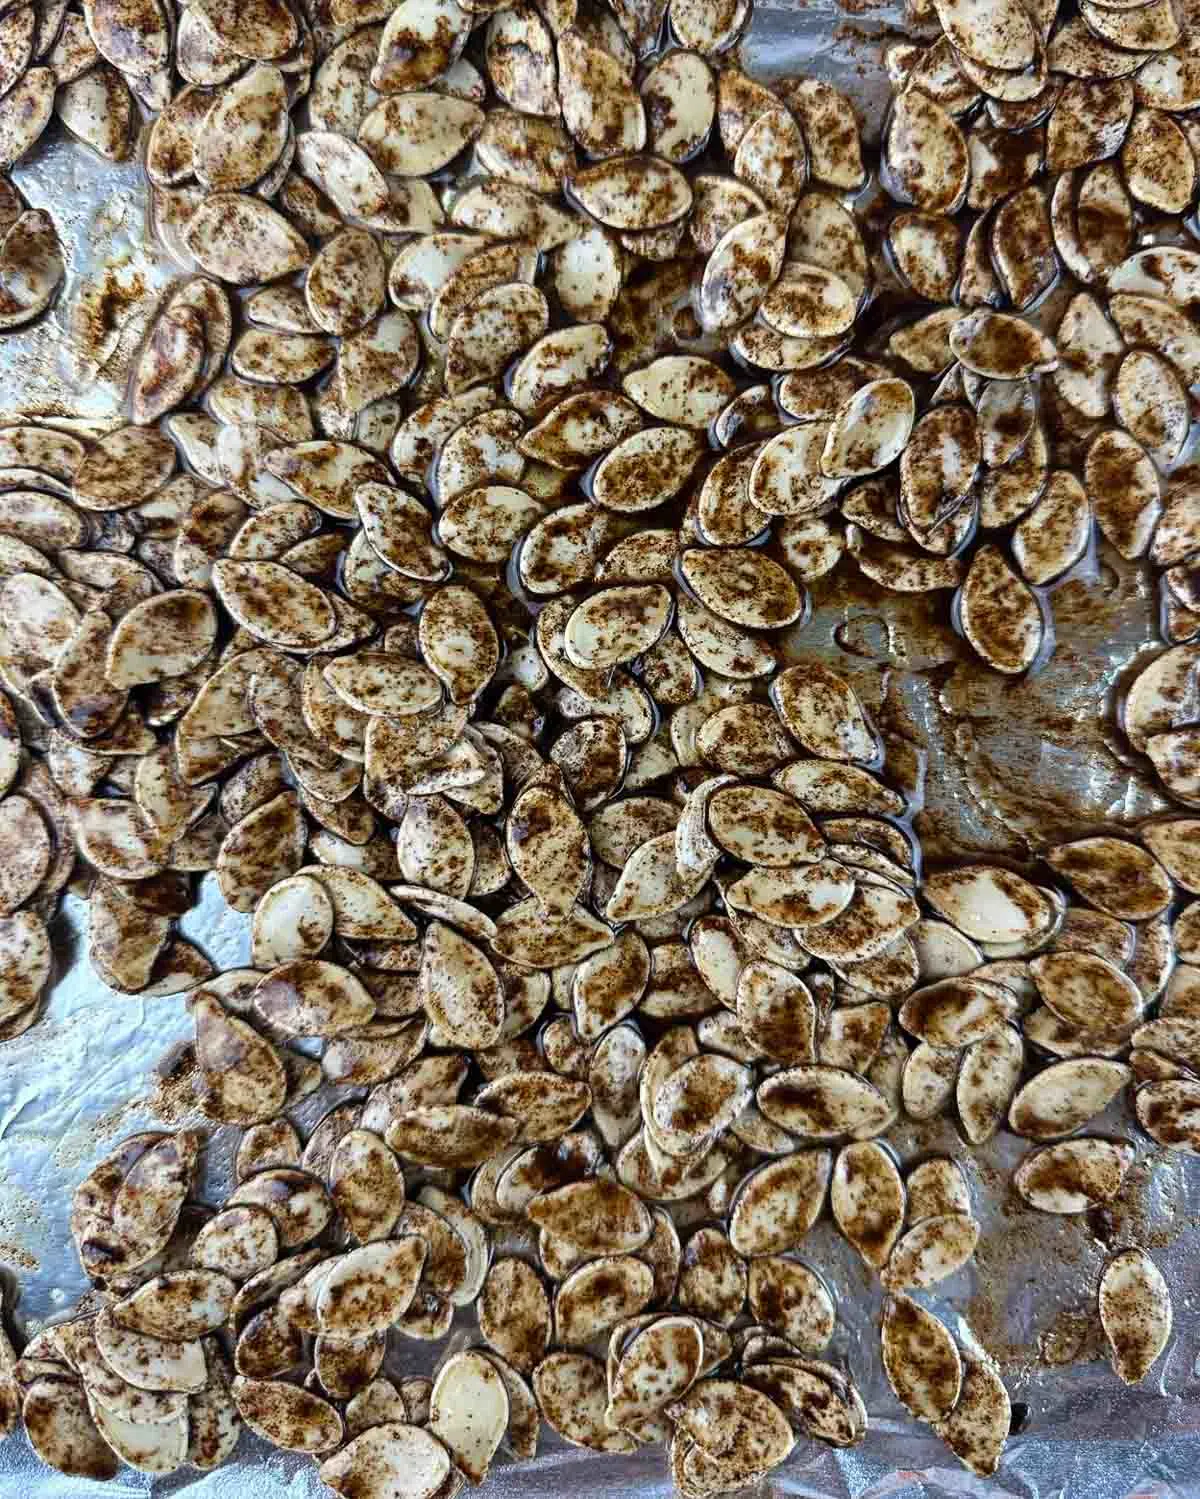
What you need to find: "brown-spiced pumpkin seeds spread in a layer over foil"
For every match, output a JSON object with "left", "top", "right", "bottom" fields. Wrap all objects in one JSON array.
[{"left": 0, "top": 0, "right": 1200, "bottom": 1499}]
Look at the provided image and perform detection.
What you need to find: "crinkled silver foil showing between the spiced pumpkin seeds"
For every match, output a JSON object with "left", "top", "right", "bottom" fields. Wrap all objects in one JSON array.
[{"left": 0, "top": 0, "right": 1200, "bottom": 1499}]
